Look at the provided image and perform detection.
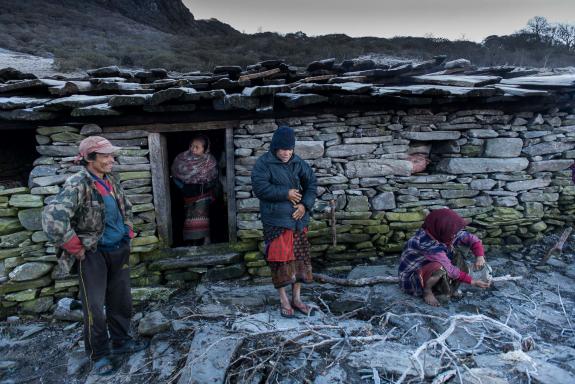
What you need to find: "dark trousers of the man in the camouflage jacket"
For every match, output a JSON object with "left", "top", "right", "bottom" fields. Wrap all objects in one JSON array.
[{"left": 78, "top": 241, "right": 132, "bottom": 360}]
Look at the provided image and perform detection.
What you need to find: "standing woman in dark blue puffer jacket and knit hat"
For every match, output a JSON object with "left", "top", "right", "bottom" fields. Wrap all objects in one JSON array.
[{"left": 252, "top": 126, "right": 317, "bottom": 317}]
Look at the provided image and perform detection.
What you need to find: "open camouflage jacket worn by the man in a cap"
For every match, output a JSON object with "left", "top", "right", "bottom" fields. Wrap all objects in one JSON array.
[{"left": 42, "top": 169, "right": 132, "bottom": 250}]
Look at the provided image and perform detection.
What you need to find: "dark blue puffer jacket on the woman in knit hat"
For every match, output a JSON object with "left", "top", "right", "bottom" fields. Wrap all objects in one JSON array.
[{"left": 252, "top": 152, "right": 317, "bottom": 231}]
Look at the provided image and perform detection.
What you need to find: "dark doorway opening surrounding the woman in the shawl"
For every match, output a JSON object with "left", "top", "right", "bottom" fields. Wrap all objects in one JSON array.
[{"left": 165, "top": 129, "right": 229, "bottom": 247}]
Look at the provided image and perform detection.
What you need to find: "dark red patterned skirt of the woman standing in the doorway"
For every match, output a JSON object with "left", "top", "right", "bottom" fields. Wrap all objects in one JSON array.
[{"left": 183, "top": 193, "right": 213, "bottom": 241}]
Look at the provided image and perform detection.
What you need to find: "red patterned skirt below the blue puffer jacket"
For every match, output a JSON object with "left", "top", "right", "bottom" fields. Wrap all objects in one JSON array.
[{"left": 264, "top": 227, "right": 313, "bottom": 288}]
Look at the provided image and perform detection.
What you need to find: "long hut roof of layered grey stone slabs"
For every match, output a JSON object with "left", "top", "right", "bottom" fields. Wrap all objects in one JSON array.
[{"left": 0, "top": 57, "right": 575, "bottom": 121}]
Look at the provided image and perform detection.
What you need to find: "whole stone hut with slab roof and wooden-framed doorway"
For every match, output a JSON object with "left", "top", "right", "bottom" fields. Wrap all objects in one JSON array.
[{"left": 0, "top": 57, "right": 575, "bottom": 316}]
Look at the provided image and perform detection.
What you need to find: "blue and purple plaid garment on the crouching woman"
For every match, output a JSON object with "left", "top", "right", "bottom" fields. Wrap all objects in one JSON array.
[{"left": 398, "top": 229, "right": 483, "bottom": 296}]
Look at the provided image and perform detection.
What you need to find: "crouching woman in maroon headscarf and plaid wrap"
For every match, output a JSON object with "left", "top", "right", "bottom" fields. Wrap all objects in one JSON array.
[{"left": 399, "top": 208, "right": 489, "bottom": 306}]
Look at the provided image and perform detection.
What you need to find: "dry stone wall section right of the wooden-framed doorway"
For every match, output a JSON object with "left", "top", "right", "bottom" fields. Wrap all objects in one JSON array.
[{"left": 234, "top": 109, "right": 575, "bottom": 277}]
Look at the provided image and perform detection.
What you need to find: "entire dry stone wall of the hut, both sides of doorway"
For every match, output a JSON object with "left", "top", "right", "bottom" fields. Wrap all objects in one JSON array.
[{"left": 0, "top": 105, "right": 575, "bottom": 316}]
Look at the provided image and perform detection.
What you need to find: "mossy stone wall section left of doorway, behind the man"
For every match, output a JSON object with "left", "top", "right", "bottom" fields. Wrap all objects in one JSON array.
[{"left": 0, "top": 125, "right": 160, "bottom": 313}]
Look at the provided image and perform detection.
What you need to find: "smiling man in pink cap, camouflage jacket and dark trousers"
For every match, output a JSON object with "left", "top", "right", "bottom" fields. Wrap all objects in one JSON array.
[{"left": 42, "top": 136, "right": 147, "bottom": 375}]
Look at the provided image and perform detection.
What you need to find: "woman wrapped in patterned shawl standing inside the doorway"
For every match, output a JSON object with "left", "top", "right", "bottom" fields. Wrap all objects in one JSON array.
[{"left": 172, "top": 135, "right": 218, "bottom": 245}]
